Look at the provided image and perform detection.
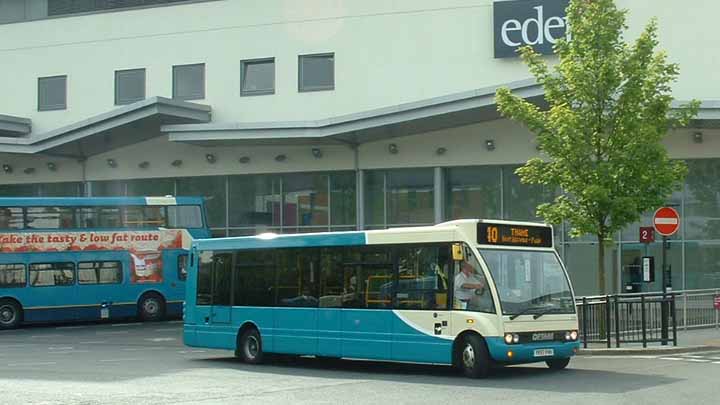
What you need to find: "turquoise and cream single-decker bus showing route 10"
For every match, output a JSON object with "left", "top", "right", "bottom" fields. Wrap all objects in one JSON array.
[{"left": 184, "top": 220, "right": 579, "bottom": 377}]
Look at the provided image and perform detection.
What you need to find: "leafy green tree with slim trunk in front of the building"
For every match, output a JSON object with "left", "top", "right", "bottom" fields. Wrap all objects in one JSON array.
[{"left": 496, "top": 0, "right": 699, "bottom": 293}]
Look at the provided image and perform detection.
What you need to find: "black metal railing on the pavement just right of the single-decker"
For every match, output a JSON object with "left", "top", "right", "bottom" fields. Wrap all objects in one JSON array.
[{"left": 576, "top": 293, "right": 677, "bottom": 348}]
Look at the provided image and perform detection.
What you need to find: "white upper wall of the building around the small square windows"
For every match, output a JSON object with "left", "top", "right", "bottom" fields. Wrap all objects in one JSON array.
[{"left": 0, "top": 0, "right": 720, "bottom": 133}]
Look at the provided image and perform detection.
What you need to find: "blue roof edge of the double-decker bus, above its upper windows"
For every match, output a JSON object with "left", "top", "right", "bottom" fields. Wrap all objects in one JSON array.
[{"left": 0, "top": 197, "right": 203, "bottom": 207}]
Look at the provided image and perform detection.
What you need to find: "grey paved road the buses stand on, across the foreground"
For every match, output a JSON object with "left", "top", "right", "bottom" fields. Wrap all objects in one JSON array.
[{"left": 0, "top": 322, "right": 720, "bottom": 405}]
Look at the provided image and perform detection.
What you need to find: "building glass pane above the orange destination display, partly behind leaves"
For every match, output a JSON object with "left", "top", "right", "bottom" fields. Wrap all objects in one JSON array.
[{"left": 503, "top": 166, "right": 556, "bottom": 222}]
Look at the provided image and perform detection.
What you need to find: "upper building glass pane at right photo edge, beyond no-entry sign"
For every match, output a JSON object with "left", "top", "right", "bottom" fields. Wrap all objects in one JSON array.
[{"left": 682, "top": 159, "right": 720, "bottom": 240}]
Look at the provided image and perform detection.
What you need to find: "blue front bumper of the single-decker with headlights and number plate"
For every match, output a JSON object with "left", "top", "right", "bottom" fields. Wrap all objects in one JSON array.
[{"left": 485, "top": 337, "right": 580, "bottom": 364}]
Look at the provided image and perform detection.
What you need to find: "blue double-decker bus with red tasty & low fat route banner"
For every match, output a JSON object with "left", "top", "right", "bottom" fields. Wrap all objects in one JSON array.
[{"left": 0, "top": 196, "right": 210, "bottom": 329}]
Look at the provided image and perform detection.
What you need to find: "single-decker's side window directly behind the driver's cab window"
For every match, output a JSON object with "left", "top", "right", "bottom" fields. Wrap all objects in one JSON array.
[{"left": 395, "top": 245, "right": 451, "bottom": 310}]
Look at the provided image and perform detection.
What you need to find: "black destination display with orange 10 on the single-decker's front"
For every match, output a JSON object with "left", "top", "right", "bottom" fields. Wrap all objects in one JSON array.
[{"left": 477, "top": 222, "right": 553, "bottom": 247}]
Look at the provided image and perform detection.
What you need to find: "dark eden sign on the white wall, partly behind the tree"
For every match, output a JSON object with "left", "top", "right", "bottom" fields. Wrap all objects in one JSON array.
[{"left": 493, "top": 0, "right": 570, "bottom": 58}]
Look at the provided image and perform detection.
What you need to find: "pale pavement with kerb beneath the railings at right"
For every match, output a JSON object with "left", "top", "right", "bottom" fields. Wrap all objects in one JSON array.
[{"left": 578, "top": 328, "right": 720, "bottom": 356}]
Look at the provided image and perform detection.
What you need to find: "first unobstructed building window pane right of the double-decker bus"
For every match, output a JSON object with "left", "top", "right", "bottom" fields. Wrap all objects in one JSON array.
[{"left": 228, "top": 176, "right": 280, "bottom": 229}]
